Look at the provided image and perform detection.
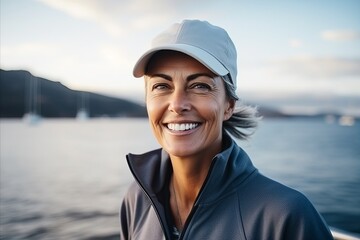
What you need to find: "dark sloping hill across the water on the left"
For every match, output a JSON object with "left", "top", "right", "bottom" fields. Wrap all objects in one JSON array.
[{"left": 0, "top": 70, "right": 147, "bottom": 118}]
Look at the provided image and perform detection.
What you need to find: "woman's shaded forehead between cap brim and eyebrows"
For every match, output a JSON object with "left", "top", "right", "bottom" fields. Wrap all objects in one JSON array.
[{"left": 146, "top": 51, "right": 215, "bottom": 75}]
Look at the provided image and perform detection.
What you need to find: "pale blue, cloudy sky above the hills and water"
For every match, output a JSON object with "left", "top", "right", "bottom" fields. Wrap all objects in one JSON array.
[{"left": 0, "top": 0, "right": 360, "bottom": 116}]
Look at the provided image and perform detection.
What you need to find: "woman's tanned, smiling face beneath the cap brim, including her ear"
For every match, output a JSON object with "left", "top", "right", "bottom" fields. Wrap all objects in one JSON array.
[{"left": 145, "top": 51, "right": 234, "bottom": 158}]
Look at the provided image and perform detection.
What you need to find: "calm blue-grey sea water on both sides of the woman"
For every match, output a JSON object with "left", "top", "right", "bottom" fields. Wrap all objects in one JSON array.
[{"left": 0, "top": 118, "right": 360, "bottom": 239}]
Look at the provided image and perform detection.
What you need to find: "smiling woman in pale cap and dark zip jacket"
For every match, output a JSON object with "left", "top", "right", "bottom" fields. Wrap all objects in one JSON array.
[{"left": 120, "top": 20, "right": 332, "bottom": 240}]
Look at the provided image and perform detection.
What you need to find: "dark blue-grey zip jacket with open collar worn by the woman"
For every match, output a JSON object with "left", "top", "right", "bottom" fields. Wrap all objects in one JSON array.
[{"left": 120, "top": 136, "right": 333, "bottom": 240}]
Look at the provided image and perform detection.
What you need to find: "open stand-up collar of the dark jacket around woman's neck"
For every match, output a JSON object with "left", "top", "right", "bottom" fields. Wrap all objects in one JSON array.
[{"left": 127, "top": 134, "right": 257, "bottom": 205}]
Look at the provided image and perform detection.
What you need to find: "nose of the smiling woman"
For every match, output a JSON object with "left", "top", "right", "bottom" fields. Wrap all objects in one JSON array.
[{"left": 168, "top": 89, "right": 191, "bottom": 114}]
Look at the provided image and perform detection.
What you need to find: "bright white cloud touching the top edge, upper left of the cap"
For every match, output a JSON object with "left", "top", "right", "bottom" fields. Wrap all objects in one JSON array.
[{"left": 38, "top": 0, "right": 210, "bottom": 37}]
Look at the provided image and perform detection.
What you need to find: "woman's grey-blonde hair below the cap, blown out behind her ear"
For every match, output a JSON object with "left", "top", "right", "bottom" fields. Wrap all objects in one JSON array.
[{"left": 221, "top": 75, "right": 261, "bottom": 140}]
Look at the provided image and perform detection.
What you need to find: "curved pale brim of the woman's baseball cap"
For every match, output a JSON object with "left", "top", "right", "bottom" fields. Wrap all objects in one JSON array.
[{"left": 133, "top": 44, "right": 229, "bottom": 78}]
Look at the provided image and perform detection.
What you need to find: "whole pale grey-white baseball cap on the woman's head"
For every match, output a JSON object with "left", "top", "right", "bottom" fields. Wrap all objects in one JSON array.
[{"left": 133, "top": 20, "right": 237, "bottom": 89}]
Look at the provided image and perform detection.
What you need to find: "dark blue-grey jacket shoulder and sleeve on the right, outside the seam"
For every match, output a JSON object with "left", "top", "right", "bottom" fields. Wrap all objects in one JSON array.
[{"left": 239, "top": 174, "right": 332, "bottom": 239}]
